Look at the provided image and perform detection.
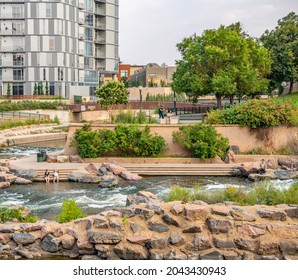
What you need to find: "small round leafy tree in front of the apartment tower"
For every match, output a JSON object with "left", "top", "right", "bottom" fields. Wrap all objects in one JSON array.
[{"left": 95, "top": 81, "right": 128, "bottom": 109}]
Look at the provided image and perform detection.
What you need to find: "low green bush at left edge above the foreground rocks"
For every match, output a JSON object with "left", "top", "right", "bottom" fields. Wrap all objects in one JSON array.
[{"left": 0, "top": 207, "right": 37, "bottom": 223}]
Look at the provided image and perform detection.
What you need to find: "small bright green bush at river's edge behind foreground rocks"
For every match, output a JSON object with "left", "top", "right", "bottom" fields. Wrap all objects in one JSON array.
[{"left": 56, "top": 199, "right": 85, "bottom": 223}]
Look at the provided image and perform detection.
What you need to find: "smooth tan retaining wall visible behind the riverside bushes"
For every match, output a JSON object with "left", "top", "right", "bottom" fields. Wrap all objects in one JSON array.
[{"left": 65, "top": 123, "right": 298, "bottom": 157}]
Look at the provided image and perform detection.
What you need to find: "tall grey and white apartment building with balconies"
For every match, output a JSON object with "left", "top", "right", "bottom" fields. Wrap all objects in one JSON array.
[{"left": 0, "top": 0, "right": 119, "bottom": 98}]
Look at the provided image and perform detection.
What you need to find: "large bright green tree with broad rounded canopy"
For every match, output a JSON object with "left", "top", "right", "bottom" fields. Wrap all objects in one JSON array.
[{"left": 172, "top": 23, "right": 271, "bottom": 108}]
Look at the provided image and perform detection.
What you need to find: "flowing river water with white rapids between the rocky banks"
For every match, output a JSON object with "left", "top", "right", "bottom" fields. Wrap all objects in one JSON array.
[{"left": 0, "top": 147, "right": 294, "bottom": 219}]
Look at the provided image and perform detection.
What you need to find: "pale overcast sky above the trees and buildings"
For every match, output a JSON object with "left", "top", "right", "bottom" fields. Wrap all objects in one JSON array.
[{"left": 119, "top": 0, "right": 298, "bottom": 66}]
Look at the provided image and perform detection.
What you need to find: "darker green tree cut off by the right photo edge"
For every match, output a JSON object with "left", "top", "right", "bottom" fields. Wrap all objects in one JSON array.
[{"left": 261, "top": 12, "right": 298, "bottom": 93}]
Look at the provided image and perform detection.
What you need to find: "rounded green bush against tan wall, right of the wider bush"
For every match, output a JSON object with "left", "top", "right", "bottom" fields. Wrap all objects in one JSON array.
[{"left": 172, "top": 124, "right": 229, "bottom": 159}]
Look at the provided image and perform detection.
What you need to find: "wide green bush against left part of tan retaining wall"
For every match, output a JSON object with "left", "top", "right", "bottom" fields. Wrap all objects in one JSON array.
[{"left": 71, "top": 124, "right": 166, "bottom": 158}]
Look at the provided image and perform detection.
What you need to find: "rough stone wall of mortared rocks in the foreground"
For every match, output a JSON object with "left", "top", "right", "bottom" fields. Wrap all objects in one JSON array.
[{"left": 0, "top": 192, "right": 298, "bottom": 260}]
